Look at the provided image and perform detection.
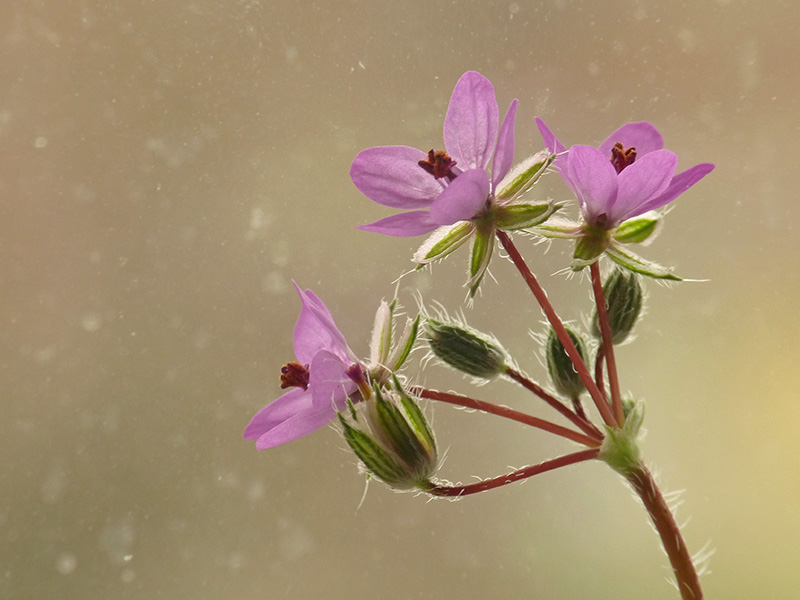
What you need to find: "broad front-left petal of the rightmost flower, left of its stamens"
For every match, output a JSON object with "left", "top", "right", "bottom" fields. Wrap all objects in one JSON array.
[{"left": 565, "top": 146, "right": 617, "bottom": 224}]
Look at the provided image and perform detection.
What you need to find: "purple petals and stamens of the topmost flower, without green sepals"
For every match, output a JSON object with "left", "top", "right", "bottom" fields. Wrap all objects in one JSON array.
[{"left": 350, "top": 71, "right": 517, "bottom": 236}]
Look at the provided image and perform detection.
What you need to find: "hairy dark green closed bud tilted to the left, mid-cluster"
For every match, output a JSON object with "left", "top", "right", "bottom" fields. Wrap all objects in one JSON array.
[{"left": 425, "top": 317, "right": 508, "bottom": 379}]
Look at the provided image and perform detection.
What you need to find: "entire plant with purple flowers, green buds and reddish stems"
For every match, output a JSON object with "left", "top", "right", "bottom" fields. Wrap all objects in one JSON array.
[{"left": 244, "top": 71, "right": 714, "bottom": 598}]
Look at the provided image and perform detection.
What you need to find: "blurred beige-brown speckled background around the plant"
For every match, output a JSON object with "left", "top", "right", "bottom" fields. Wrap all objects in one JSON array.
[{"left": 0, "top": 0, "right": 800, "bottom": 600}]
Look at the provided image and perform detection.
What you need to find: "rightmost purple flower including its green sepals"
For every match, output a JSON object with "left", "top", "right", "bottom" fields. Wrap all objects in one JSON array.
[{"left": 536, "top": 118, "right": 714, "bottom": 275}]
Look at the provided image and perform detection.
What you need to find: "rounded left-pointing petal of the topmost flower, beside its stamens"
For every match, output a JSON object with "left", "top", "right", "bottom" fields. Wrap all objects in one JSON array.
[{"left": 350, "top": 146, "right": 442, "bottom": 209}]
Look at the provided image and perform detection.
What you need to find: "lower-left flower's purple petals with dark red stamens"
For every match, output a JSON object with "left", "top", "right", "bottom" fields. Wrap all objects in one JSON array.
[{"left": 244, "top": 284, "right": 366, "bottom": 450}]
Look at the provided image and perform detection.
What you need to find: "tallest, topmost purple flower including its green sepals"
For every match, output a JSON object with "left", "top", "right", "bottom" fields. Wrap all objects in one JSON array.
[{"left": 350, "top": 71, "right": 556, "bottom": 293}]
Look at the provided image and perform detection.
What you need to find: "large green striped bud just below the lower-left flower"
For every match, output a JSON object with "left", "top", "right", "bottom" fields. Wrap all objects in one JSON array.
[{"left": 339, "top": 378, "right": 438, "bottom": 490}]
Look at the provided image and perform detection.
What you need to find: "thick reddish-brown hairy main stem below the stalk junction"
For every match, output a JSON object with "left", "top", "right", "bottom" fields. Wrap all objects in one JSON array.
[{"left": 625, "top": 464, "right": 703, "bottom": 600}]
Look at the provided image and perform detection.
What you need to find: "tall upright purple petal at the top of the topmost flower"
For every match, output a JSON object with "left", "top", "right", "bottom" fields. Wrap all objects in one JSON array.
[{"left": 444, "top": 71, "right": 500, "bottom": 169}]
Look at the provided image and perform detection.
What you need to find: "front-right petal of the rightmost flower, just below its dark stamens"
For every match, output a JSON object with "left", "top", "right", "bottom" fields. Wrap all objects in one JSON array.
[{"left": 608, "top": 150, "right": 678, "bottom": 225}]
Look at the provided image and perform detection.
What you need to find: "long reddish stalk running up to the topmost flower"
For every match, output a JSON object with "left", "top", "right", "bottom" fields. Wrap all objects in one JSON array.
[{"left": 497, "top": 229, "right": 617, "bottom": 427}]
